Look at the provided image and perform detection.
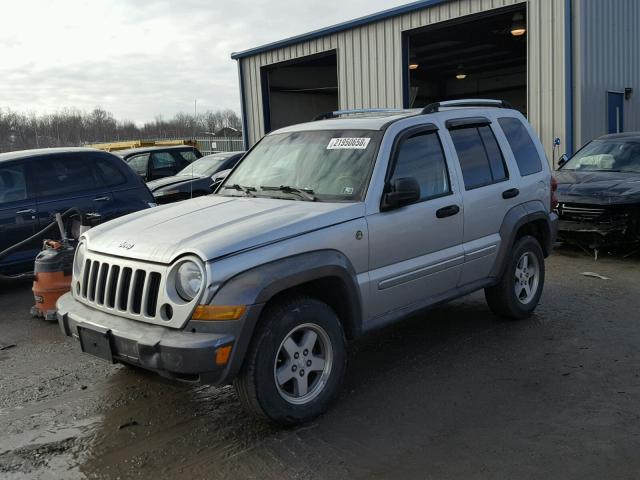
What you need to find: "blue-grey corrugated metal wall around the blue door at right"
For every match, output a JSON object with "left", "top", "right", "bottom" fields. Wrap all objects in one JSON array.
[{"left": 574, "top": 0, "right": 640, "bottom": 145}]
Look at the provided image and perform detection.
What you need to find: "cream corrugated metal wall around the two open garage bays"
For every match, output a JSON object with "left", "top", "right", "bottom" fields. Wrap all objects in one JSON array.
[{"left": 240, "top": 0, "right": 565, "bottom": 161}]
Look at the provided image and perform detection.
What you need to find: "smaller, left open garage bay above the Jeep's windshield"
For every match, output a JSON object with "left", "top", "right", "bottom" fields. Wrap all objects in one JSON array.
[{"left": 261, "top": 50, "right": 339, "bottom": 133}]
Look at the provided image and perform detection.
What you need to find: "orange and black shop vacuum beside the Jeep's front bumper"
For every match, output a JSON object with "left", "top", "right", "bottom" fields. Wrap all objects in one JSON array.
[{"left": 31, "top": 240, "right": 75, "bottom": 321}]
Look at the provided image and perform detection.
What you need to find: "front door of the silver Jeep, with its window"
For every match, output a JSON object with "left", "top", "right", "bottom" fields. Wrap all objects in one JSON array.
[{"left": 367, "top": 127, "right": 464, "bottom": 318}]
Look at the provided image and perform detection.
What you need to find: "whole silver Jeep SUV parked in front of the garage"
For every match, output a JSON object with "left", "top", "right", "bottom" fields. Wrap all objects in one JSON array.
[{"left": 58, "top": 100, "right": 557, "bottom": 424}]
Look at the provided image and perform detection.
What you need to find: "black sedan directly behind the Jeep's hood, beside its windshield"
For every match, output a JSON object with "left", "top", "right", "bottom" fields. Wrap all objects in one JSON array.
[{"left": 147, "top": 152, "right": 244, "bottom": 203}]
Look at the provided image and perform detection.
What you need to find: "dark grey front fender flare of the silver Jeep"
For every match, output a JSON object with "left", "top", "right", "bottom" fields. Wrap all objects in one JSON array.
[{"left": 210, "top": 250, "right": 363, "bottom": 378}]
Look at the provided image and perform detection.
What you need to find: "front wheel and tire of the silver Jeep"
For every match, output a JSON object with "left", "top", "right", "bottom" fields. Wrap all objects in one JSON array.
[{"left": 234, "top": 297, "right": 347, "bottom": 426}]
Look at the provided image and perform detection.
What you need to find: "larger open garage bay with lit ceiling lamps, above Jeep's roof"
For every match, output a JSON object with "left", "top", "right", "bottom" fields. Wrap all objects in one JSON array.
[{"left": 404, "top": 4, "right": 527, "bottom": 115}]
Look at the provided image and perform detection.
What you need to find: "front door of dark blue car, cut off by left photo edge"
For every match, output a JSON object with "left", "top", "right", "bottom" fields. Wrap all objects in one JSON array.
[{"left": 0, "top": 161, "right": 39, "bottom": 273}]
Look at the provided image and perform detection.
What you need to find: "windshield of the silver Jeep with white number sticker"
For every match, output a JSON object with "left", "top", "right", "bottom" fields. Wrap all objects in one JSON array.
[{"left": 219, "top": 130, "right": 380, "bottom": 201}]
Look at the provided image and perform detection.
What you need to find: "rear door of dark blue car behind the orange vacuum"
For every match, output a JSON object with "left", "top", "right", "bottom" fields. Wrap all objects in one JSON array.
[{"left": 31, "top": 152, "right": 113, "bottom": 231}]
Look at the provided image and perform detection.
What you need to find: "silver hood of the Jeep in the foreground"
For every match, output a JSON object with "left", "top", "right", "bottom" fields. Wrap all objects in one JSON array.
[{"left": 84, "top": 195, "right": 365, "bottom": 264}]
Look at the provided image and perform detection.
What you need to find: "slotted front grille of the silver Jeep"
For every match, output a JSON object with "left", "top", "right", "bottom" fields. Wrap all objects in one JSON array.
[{"left": 79, "top": 258, "right": 162, "bottom": 318}]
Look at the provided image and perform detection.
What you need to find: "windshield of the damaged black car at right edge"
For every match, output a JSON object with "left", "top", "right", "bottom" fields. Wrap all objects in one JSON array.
[{"left": 561, "top": 139, "right": 640, "bottom": 173}]
